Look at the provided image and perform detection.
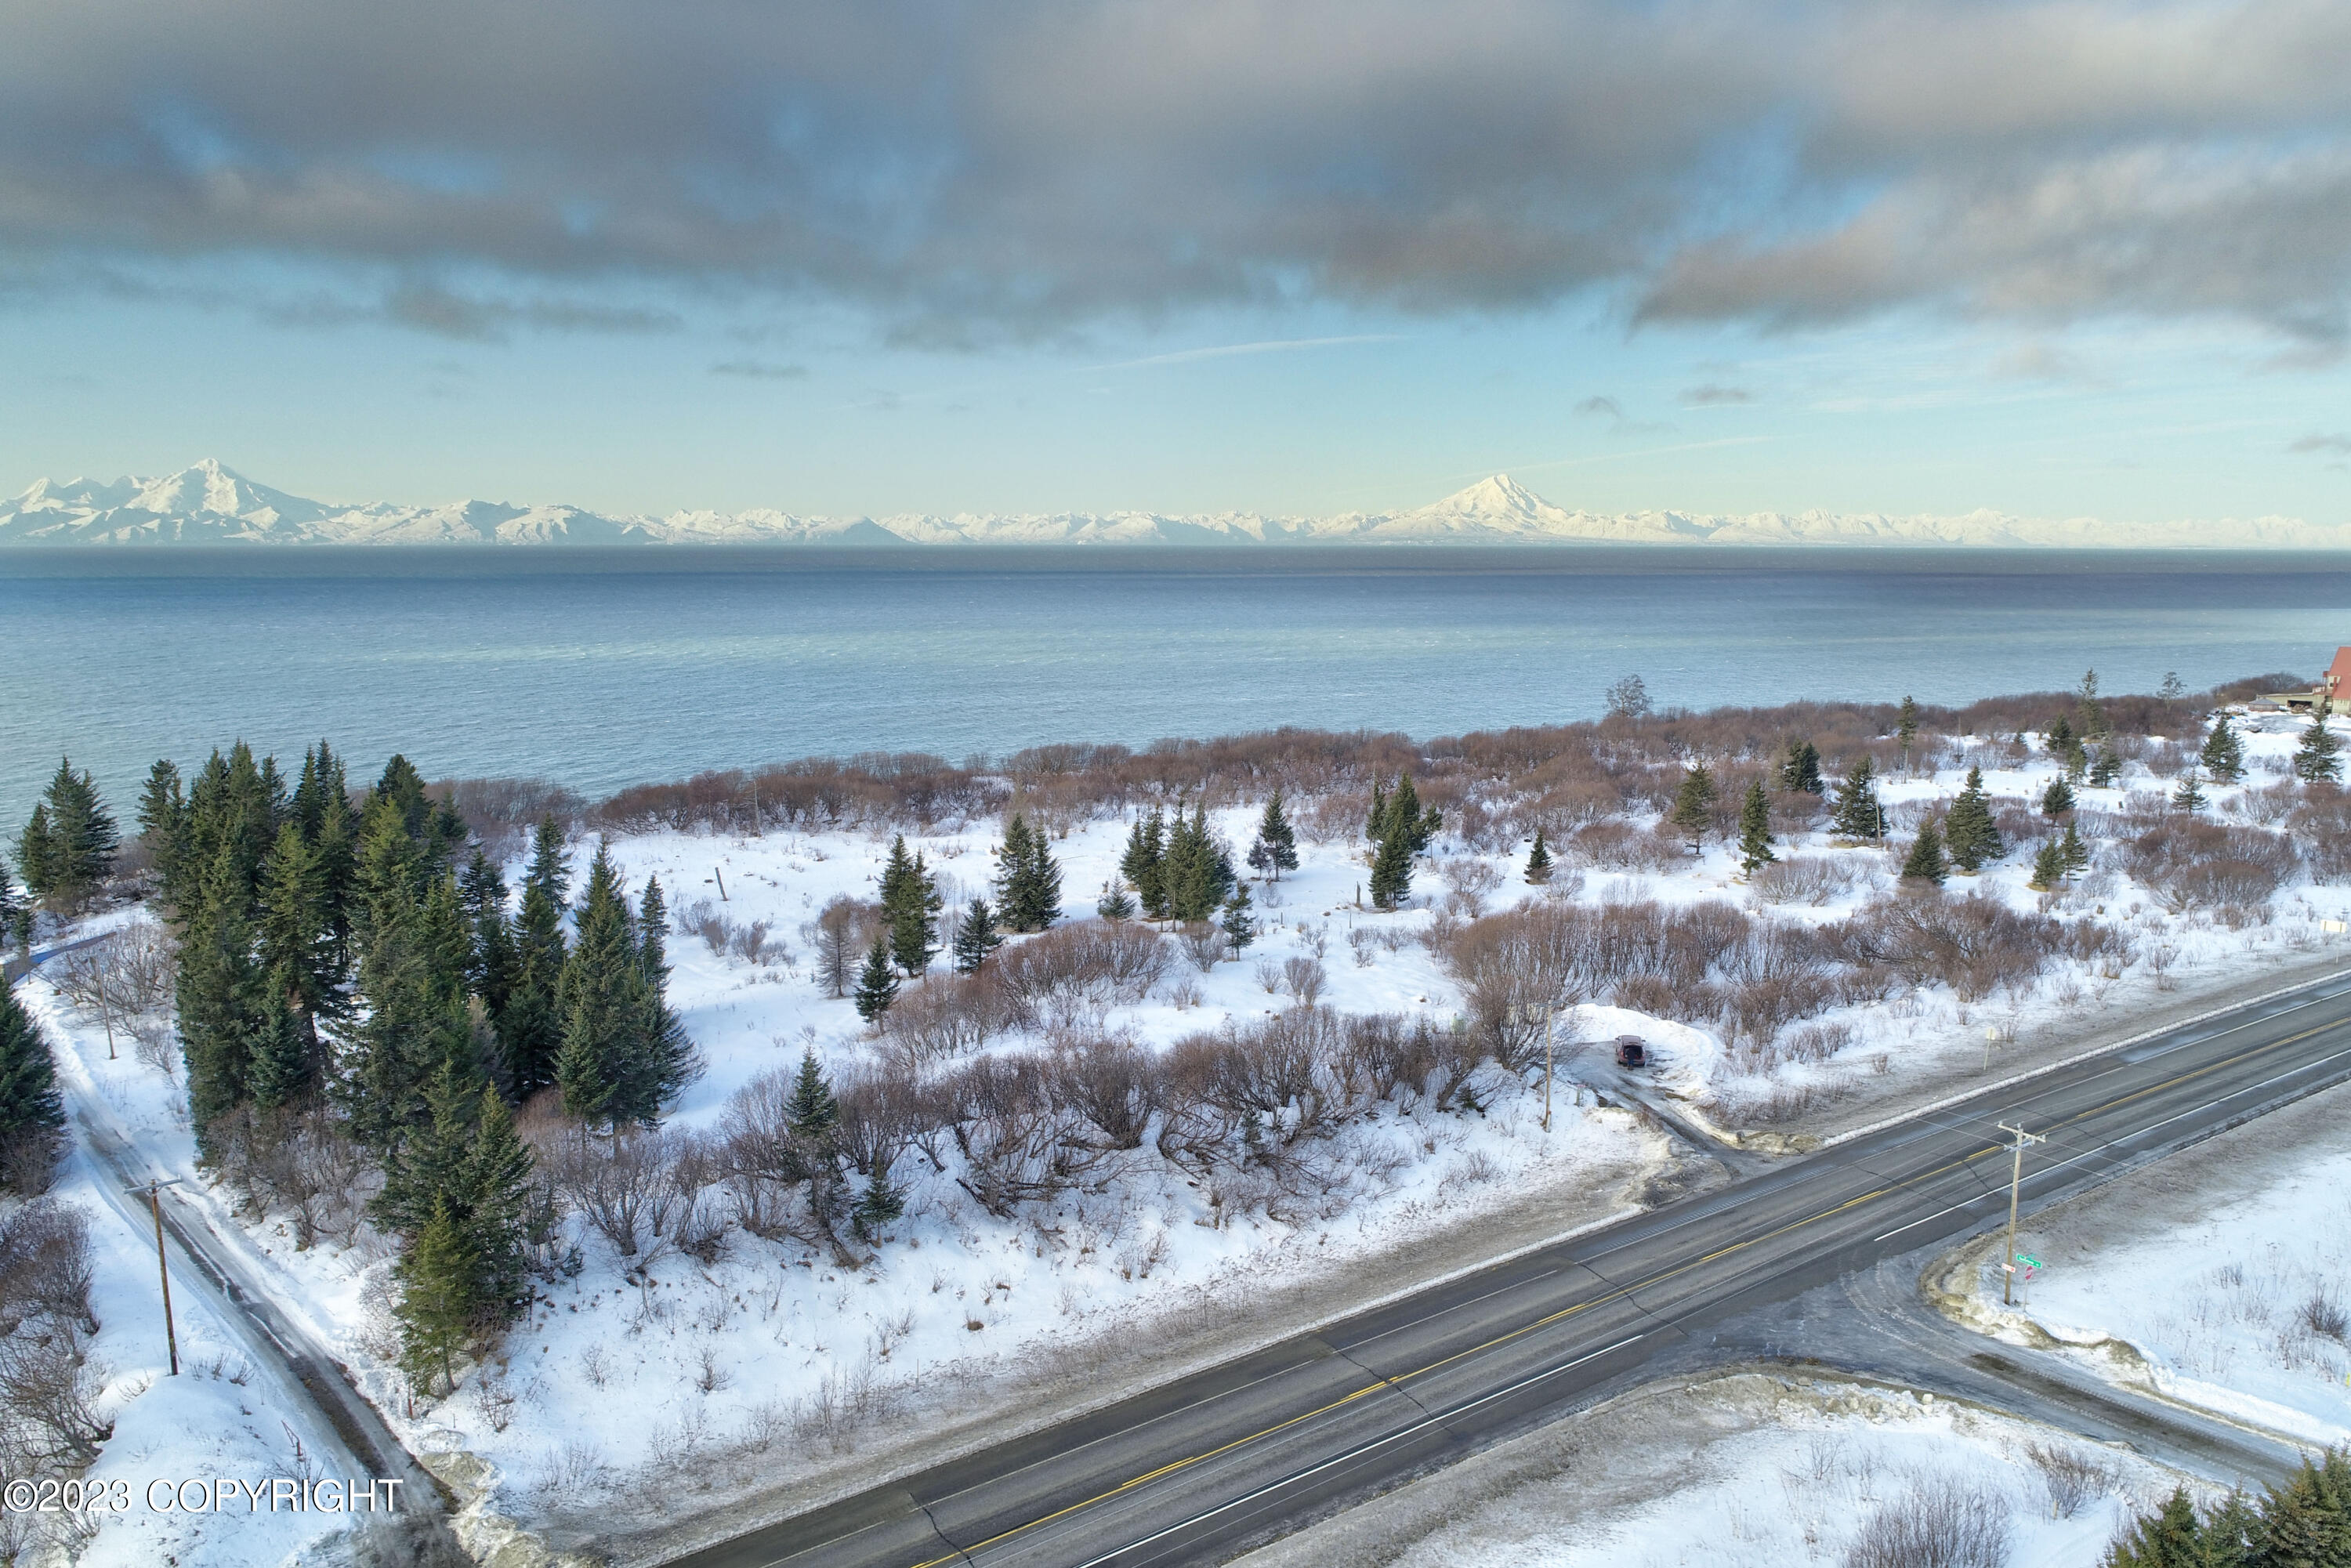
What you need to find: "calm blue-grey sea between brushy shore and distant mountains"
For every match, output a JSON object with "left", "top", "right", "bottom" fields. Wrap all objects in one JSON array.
[{"left": 0, "top": 548, "right": 2351, "bottom": 825}]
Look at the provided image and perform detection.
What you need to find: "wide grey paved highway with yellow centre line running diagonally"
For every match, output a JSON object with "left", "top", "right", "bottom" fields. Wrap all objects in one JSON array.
[{"left": 679, "top": 980, "right": 2351, "bottom": 1568}]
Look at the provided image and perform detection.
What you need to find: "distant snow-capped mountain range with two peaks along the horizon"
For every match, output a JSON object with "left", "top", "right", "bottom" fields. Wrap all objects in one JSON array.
[{"left": 0, "top": 458, "right": 2351, "bottom": 550}]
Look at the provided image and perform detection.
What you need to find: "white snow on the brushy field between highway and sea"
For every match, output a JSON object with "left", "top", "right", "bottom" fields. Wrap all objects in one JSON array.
[{"left": 26, "top": 719, "right": 2351, "bottom": 1561}]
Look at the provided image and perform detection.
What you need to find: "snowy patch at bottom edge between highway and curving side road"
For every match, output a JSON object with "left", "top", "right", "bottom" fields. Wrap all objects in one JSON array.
[{"left": 1241, "top": 1373, "right": 2205, "bottom": 1568}]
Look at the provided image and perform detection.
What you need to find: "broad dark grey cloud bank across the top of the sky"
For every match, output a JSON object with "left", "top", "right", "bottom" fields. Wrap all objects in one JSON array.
[{"left": 0, "top": 0, "right": 2351, "bottom": 346}]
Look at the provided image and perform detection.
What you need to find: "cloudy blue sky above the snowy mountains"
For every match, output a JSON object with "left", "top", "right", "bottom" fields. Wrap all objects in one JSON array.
[{"left": 0, "top": 0, "right": 2351, "bottom": 522}]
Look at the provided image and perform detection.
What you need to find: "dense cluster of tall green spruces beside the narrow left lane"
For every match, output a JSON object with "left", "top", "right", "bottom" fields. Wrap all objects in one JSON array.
[{"left": 110, "top": 743, "right": 696, "bottom": 1382}]
